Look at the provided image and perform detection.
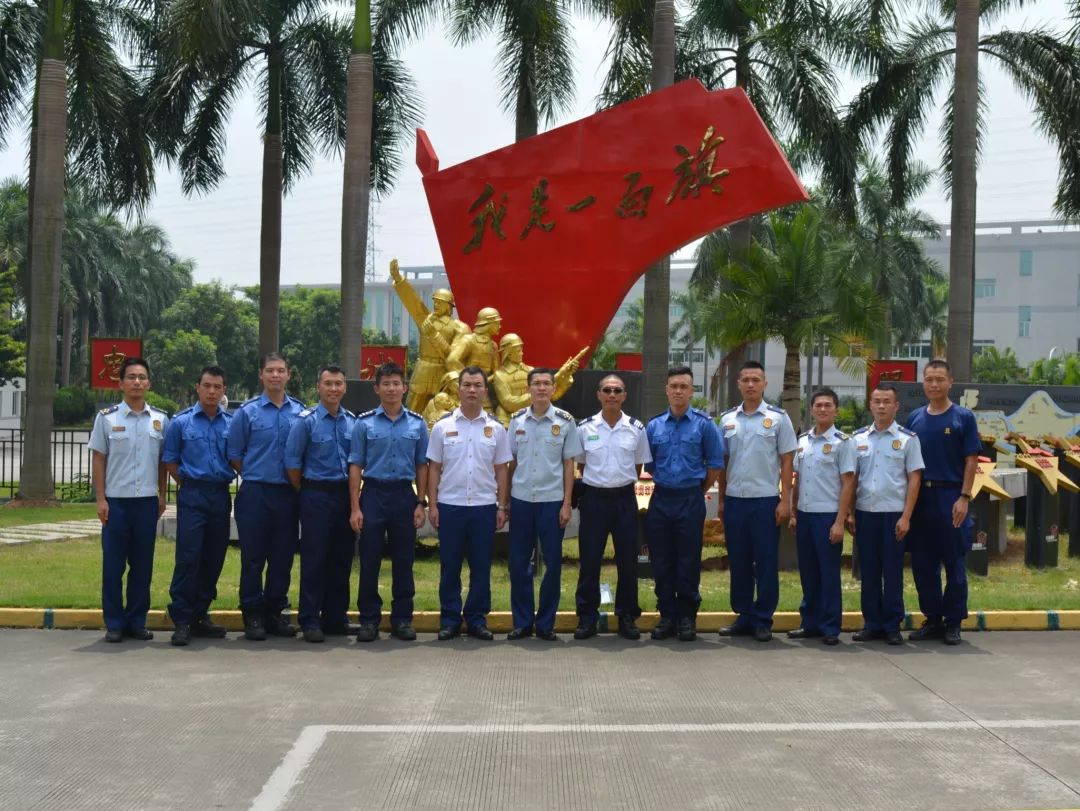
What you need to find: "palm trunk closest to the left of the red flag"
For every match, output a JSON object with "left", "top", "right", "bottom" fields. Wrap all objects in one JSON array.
[{"left": 341, "top": 0, "right": 375, "bottom": 377}]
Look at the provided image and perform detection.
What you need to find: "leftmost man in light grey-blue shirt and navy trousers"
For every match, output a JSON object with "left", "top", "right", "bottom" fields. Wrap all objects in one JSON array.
[{"left": 89, "top": 356, "right": 168, "bottom": 643}]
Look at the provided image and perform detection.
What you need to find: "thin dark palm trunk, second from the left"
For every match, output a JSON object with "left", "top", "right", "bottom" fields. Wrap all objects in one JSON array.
[{"left": 259, "top": 52, "right": 282, "bottom": 356}]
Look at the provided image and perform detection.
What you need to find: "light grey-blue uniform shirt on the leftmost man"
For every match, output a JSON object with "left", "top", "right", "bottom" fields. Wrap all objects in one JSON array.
[{"left": 87, "top": 403, "right": 168, "bottom": 499}]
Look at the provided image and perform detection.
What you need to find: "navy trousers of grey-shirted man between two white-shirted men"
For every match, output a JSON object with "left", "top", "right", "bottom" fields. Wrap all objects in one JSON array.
[{"left": 507, "top": 498, "right": 563, "bottom": 631}]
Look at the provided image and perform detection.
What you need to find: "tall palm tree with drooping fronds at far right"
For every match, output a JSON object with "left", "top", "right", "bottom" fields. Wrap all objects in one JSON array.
[{"left": 848, "top": 0, "right": 1080, "bottom": 380}]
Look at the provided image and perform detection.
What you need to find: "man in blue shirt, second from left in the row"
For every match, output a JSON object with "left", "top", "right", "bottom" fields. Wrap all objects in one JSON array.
[{"left": 162, "top": 366, "right": 237, "bottom": 647}]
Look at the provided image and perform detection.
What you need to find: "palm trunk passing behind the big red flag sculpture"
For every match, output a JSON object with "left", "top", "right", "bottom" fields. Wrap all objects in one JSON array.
[{"left": 642, "top": 0, "right": 675, "bottom": 415}]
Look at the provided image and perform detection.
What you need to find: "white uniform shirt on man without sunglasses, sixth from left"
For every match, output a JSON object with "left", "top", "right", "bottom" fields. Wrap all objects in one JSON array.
[{"left": 428, "top": 407, "right": 513, "bottom": 506}]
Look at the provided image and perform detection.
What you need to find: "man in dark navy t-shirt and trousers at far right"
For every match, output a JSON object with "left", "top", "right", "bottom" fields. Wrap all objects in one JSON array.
[{"left": 907, "top": 361, "right": 982, "bottom": 645}]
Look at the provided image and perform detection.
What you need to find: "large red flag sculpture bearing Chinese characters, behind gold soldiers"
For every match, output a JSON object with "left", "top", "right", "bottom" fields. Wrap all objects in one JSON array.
[{"left": 416, "top": 80, "right": 808, "bottom": 367}]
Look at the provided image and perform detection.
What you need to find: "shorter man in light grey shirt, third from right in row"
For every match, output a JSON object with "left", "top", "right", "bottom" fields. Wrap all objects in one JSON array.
[{"left": 787, "top": 389, "right": 855, "bottom": 645}]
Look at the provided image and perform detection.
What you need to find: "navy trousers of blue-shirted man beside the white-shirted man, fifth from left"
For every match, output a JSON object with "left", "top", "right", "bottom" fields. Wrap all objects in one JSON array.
[{"left": 356, "top": 479, "right": 416, "bottom": 623}]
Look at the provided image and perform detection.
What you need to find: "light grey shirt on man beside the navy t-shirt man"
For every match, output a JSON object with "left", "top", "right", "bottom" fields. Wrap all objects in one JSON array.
[{"left": 852, "top": 421, "right": 926, "bottom": 513}]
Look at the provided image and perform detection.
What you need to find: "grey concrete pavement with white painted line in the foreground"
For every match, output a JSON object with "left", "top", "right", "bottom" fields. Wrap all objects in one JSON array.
[{"left": 0, "top": 631, "right": 1080, "bottom": 811}]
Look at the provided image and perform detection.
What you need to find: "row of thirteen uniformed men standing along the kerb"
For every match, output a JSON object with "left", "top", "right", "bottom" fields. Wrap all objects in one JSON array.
[{"left": 90, "top": 353, "right": 980, "bottom": 646}]
